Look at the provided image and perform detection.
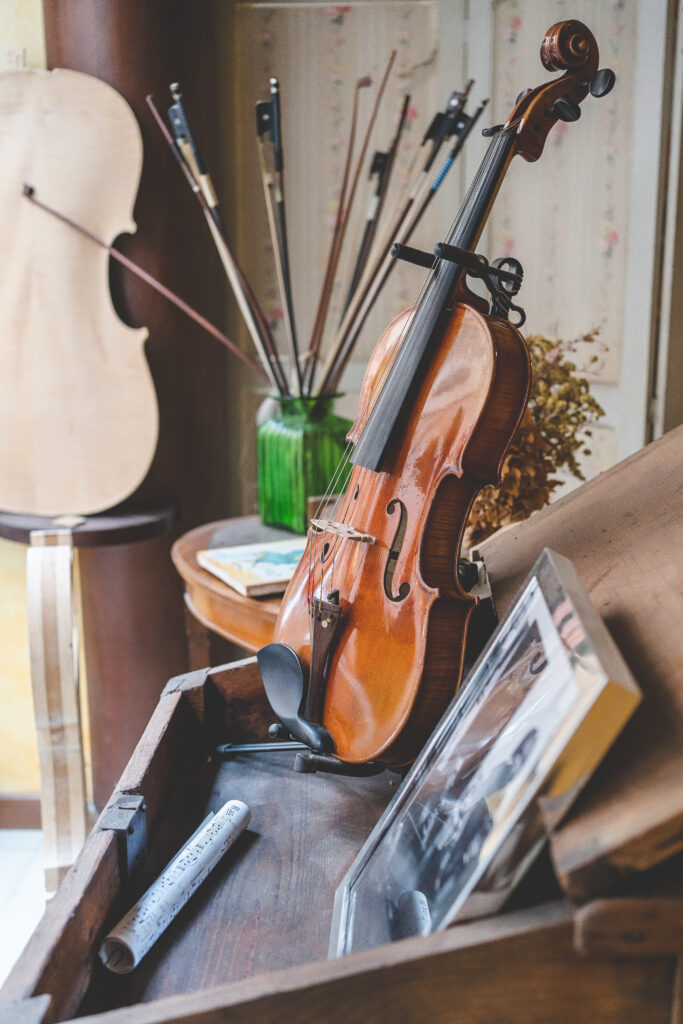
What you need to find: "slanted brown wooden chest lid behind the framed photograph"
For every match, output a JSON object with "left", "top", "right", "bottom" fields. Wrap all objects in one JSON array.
[{"left": 480, "top": 427, "right": 683, "bottom": 899}]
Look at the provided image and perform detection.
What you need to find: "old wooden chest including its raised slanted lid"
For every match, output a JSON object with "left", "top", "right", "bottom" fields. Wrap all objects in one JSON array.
[{"left": 0, "top": 430, "right": 683, "bottom": 1024}]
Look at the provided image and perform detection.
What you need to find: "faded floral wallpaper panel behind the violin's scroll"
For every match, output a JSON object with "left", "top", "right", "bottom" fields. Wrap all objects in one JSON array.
[{"left": 489, "top": 0, "right": 637, "bottom": 383}]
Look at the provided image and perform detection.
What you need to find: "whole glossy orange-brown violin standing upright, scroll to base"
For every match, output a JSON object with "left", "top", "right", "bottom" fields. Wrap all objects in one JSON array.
[{"left": 258, "top": 20, "right": 614, "bottom": 767}]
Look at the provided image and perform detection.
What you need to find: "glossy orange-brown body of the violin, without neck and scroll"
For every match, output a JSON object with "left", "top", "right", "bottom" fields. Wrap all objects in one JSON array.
[{"left": 275, "top": 296, "right": 530, "bottom": 765}]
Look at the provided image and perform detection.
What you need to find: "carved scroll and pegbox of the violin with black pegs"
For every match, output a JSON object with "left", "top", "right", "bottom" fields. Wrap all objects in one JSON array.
[{"left": 506, "top": 20, "right": 615, "bottom": 162}]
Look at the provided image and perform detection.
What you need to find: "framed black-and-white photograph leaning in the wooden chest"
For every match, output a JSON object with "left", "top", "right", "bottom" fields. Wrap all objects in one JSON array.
[{"left": 330, "top": 550, "right": 640, "bottom": 956}]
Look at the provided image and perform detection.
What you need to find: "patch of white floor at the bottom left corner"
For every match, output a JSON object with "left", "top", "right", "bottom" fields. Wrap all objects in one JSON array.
[{"left": 0, "top": 828, "right": 45, "bottom": 985}]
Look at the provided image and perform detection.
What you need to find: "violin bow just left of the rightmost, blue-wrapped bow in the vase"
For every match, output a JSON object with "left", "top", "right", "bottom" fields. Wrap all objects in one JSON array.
[{"left": 317, "top": 79, "right": 474, "bottom": 395}]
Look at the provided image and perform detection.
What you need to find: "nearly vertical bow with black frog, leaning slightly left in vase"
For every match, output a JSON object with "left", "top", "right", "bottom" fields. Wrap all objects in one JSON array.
[{"left": 256, "top": 78, "right": 303, "bottom": 394}]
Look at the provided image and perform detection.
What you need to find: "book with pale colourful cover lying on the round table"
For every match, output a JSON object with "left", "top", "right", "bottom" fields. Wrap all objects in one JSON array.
[{"left": 197, "top": 537, "right": 306, "bottom": 597}]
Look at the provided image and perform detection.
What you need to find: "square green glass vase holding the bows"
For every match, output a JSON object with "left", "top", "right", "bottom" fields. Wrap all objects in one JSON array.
[{"left": 257, "top": 395, "right": 351, "bottom": 534}]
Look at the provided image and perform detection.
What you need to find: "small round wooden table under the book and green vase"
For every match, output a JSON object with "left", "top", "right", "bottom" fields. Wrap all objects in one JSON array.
[{"left": 171, "top": 515, "right": 293, "bottom": 651}]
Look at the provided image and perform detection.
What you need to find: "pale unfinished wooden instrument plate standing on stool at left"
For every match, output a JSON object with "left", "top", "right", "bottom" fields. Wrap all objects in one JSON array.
[{"left": 0, "top": 70, "right": 159, "bottom": 516}]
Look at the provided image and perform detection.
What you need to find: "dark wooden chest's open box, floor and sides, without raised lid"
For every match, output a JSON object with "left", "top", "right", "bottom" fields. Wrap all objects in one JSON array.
[{"left": 0, "top": 658, "right": 683, "bottom": 1024}]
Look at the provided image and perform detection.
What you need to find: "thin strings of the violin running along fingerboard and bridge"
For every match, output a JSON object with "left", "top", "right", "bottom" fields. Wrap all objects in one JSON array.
[{"left": 309, "top": 126, "right": 521, "bottom": 600}]
